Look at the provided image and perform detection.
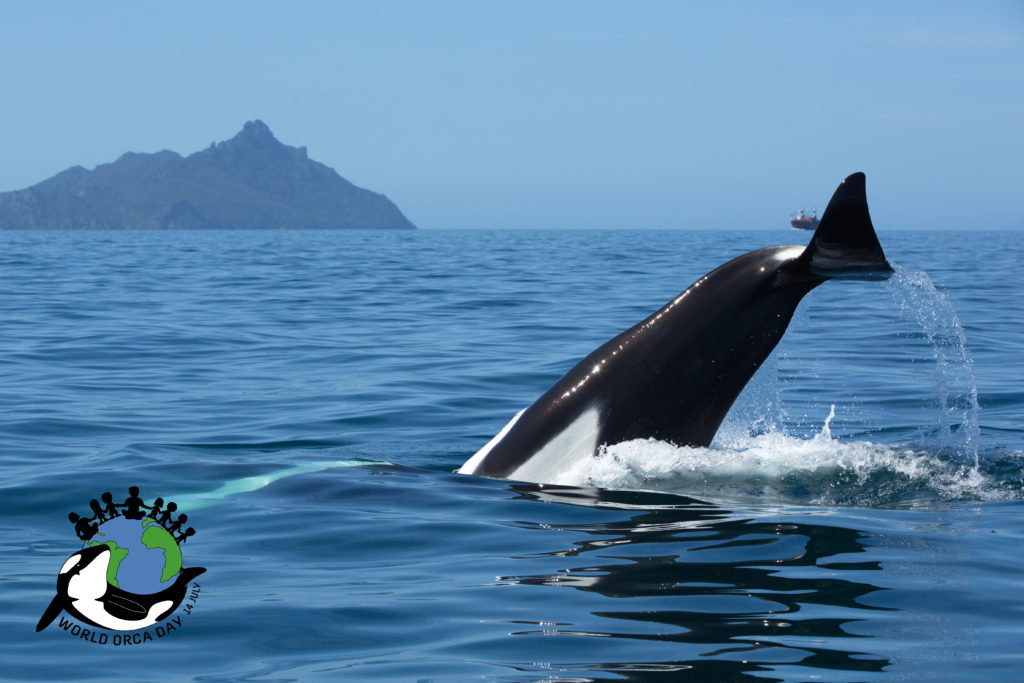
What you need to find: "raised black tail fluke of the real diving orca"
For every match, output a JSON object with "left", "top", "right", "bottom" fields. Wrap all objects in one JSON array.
[{"left": 801, "top": 172, "right": 893, "bottom": 280}]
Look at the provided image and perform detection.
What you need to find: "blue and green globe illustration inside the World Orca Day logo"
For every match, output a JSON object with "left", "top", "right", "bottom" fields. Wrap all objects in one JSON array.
[{"left": 85, "top": 516, "right": 181, "bottom": 594}]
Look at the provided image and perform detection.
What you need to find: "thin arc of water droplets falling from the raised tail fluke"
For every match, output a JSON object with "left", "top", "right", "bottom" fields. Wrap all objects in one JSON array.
[{"left": 888, "top": 266, "right": 981, "bottom": 470}]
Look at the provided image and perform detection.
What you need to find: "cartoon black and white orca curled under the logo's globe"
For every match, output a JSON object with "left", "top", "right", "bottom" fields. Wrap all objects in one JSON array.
[{"left": 36, "top": 544, "right": 206, "bottom": 632}]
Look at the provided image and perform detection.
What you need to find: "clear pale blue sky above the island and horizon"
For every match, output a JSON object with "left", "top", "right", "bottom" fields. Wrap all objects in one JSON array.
[{"left": 0, "top": 0, "right": 1024, "bottom": 229}]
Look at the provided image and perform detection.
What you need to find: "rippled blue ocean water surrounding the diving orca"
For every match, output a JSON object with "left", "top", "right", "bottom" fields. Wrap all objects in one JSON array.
[{"left": 0, "top": 227, "right": 1024, "bottom": 682}]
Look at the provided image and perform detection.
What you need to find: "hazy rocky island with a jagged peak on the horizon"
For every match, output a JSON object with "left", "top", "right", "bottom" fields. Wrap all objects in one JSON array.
[{"left": 0, "top": 121, "right": 416, "bottom": 229}]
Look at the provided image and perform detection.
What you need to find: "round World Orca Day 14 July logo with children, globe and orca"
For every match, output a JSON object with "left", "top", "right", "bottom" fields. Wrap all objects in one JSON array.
[{"left": 36, "top": 486, "right": 206, "bottom": 645}]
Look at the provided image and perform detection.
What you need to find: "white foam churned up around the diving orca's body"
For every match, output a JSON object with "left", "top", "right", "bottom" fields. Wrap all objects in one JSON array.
[{"left": 552, "top": 407, "right": 1024, "bottom": 507}]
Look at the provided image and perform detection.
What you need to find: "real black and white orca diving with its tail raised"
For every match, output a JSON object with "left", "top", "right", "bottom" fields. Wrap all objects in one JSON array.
[{"left": 459, "top": 173, "right": 893, "bottom": 483}]
